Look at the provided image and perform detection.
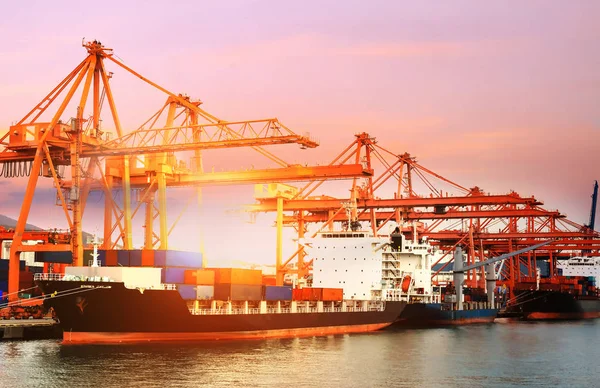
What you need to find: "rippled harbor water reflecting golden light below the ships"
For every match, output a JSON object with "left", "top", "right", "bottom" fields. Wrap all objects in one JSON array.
[{"left": 0, "top": 320, "right": 600, "bottom": 388}]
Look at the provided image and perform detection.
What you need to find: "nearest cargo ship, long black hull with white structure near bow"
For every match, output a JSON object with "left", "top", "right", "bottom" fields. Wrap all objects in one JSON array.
[{"left": 35, "top": 247, "right": 406, "bottom": 344}]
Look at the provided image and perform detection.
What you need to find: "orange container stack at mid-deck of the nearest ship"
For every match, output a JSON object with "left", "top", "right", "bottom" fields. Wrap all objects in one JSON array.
[{"left": 212, "top": 268, "right": 263, "bottom": 301}]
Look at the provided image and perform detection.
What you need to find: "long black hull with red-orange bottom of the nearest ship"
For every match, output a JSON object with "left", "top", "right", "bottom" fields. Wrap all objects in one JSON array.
[{"left": 38, "top": 280, "right": 406, "bottom": 343}]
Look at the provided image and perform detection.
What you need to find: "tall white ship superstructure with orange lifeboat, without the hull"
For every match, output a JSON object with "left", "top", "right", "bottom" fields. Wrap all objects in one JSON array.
[{"left": 301, "top": 231, "right": 433, "bottom": 302}]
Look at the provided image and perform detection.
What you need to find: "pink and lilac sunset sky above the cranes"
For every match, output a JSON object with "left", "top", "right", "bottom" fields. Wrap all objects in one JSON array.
[{"left": 0, "top": 1, "right": 600, "bottom": 264}]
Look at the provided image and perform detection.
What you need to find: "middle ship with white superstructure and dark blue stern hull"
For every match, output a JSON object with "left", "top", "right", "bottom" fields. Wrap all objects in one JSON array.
[{"left": 301, "top": 228, "right": 498, "bottom": 327}]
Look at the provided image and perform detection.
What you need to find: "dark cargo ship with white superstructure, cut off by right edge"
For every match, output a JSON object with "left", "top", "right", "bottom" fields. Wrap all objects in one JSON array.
[{"left": 501, "top": 257, "right": 600, "bottom": 321}]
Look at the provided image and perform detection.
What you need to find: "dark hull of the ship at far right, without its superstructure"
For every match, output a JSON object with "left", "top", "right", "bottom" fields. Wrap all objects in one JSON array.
[{"left": 502, "top": 290, "right": 600, "bottom": 321}]
